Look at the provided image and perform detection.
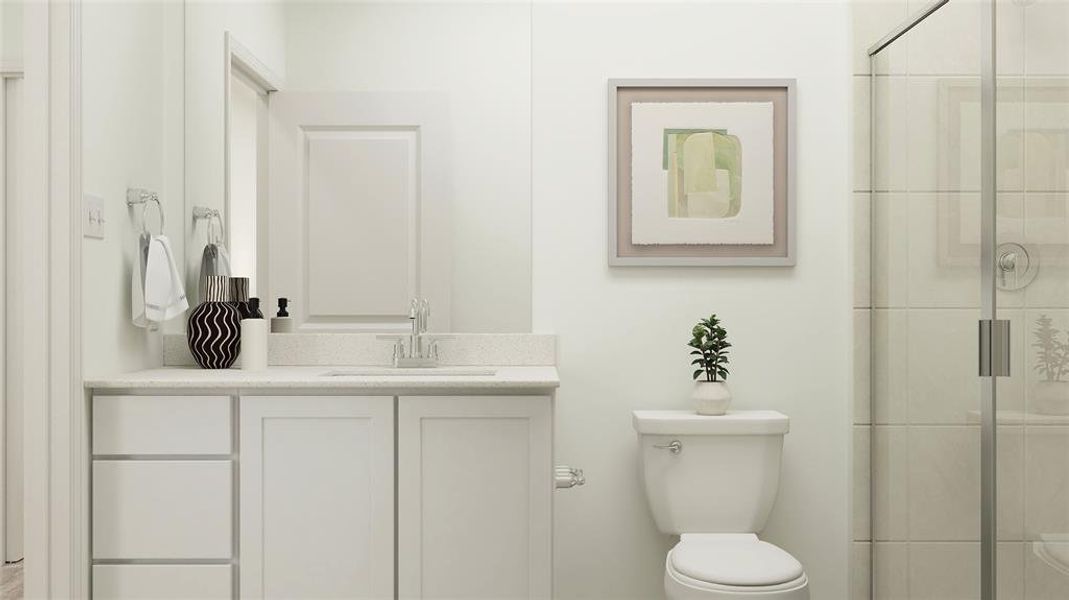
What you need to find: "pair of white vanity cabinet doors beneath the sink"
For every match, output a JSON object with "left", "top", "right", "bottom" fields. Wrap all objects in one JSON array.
[{"left": 241, "top": 396, "right": 554, "bottom": 600}]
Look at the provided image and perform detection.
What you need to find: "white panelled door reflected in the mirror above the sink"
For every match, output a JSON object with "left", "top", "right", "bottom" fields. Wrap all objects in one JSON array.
[{"left": 266, "top": 91, "right": 452, "bottom": 333}]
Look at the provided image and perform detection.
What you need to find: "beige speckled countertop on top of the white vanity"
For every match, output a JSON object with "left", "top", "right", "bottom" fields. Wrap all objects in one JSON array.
[{"left": 84, "top": 366, "right": 560, "bottom": 394}]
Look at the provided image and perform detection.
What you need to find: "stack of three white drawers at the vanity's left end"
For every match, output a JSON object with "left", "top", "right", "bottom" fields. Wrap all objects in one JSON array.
[{"left": 91, "top": 395, "right": 234, "bottom": 600}]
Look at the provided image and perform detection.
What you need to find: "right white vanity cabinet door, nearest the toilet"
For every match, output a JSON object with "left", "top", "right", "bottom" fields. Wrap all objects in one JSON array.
[{"left": 398, "top": 396, "right": 553, "bottom": 600}]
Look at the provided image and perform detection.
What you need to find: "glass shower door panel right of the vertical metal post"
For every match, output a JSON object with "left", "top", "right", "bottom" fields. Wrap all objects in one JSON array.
[{"left": 993, "top": 0, "right": 1069, "bottom": 600}]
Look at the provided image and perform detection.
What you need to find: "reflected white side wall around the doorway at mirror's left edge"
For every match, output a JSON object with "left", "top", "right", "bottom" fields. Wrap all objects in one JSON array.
[{"left": 182, "top": 2, "right": 285, "bottom": 299}]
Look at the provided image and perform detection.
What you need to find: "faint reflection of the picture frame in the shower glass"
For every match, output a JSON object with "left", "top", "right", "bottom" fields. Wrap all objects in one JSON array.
[{"left": 936, "top": 77, "right": 1069, "bottom": 268}]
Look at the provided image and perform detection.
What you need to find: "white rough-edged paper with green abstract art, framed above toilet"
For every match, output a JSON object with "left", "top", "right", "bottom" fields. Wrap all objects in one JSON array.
[{"left": 630, "top": 97, "right": 776, "bottom": 246}]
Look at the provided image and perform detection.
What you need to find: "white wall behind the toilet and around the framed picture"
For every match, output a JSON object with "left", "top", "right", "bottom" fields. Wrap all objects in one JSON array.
[{"left": 532, "top": 2, "right": 851, "bottom": 599}]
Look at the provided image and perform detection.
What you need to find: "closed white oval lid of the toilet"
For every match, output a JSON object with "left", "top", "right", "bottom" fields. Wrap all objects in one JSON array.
[{"left": 671, "top": 536, "right": 804, "bottom": 586}]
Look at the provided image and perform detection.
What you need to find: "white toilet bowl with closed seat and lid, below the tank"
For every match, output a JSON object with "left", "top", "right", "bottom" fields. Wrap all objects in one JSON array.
[{"left": 665, "top": 534, "right": 809, "bottom": 600}]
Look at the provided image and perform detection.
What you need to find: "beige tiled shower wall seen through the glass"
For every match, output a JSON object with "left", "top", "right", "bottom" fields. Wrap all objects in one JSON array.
[{"left": 851, "top": 0, "right": 1069, "bottom": 600}]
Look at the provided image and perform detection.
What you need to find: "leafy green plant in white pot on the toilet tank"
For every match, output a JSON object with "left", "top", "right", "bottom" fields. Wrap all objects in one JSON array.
[{"left": 687, "top": 314, "right": 731, "bottom": 415}]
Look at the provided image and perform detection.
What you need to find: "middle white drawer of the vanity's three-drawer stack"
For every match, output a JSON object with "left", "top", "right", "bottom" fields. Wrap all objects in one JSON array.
[{"left": 93, "top": 460, "right": 233, "bottom": 559}]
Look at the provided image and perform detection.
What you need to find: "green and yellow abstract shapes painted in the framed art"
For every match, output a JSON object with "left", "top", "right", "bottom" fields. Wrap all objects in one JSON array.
[{"left": 661, "top": 128, "right": 742, "bottom": 219}]
